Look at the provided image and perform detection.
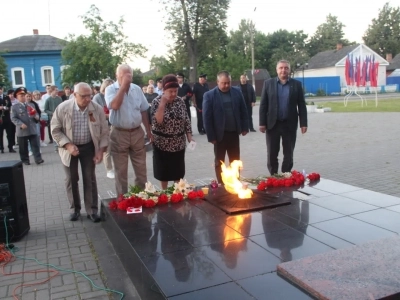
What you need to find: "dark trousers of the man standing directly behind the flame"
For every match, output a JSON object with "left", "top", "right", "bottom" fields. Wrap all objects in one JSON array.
[{"left": 214, "top": 131, "right": 240, "bottom": 183}]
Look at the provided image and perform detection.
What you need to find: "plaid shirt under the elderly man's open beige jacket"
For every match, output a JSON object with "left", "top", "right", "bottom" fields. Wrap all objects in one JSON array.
[{"left": 72, "top": 102, "right": 92, "bottom": 145}]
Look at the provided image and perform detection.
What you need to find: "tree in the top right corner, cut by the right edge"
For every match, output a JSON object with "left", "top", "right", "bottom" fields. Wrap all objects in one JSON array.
[{"left": 363, "top": 3, "right": 400, "bottom": 57}]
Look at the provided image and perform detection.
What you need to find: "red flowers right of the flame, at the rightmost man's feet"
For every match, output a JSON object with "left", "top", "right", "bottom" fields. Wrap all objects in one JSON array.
[{"left": 253, "top": 170, "right": 320, "bottom": 191}]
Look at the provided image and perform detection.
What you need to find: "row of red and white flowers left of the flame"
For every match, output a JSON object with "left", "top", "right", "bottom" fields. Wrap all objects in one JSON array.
[{"left": 108, "top": 179, "right": 204, "bottom": 211}]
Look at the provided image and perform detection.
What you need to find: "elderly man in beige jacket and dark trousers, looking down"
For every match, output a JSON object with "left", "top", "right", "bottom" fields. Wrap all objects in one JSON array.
[{"left": 51, "top": 82, "right": 108, "bottom": 223}]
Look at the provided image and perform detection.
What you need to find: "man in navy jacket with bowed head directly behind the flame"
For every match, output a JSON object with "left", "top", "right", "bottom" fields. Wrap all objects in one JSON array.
[{"left": 203, "top": 71, "right": 249, "bottom": 183}]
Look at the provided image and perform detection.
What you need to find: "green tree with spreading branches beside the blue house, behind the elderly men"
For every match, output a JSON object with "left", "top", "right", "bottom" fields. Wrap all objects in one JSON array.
[{"left": 61, "top": 5, "right": 147, "bottom": 83}]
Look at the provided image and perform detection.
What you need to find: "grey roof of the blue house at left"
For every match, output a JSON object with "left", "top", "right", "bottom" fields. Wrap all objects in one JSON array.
[{"left": 0, "top": 34, "right": 64, "bottom": 52}]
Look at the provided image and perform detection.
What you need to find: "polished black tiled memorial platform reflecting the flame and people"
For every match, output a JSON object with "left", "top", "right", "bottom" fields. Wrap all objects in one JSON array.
[{"left": 102, "top": 179, "right": 400, "bottom": 300}]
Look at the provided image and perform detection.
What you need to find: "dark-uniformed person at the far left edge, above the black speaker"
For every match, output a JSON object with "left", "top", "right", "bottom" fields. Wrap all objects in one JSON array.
[{"left": 0, "top": 86, "right": 15, "bottom": 153}]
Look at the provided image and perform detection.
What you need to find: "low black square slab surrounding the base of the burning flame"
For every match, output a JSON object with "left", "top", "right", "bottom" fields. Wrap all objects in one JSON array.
[{"left": 205, "top": 187, "right": 290, "bottom": 214}]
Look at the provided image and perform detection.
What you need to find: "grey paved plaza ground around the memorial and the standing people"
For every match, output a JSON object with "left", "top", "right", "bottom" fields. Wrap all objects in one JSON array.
[{"left": 0, "top": 106, "right": 400, "bottom": 300}]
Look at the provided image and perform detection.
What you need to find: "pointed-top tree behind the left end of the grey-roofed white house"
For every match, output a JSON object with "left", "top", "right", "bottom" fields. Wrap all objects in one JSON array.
[{"left": 308, "top": 14, "right": 353, "bottom": 57}]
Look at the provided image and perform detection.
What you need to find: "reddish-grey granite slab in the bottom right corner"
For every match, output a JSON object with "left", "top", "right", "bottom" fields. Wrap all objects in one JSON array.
[{"left": 278, "top": 237, "right": 400, "bottom": 300}]
